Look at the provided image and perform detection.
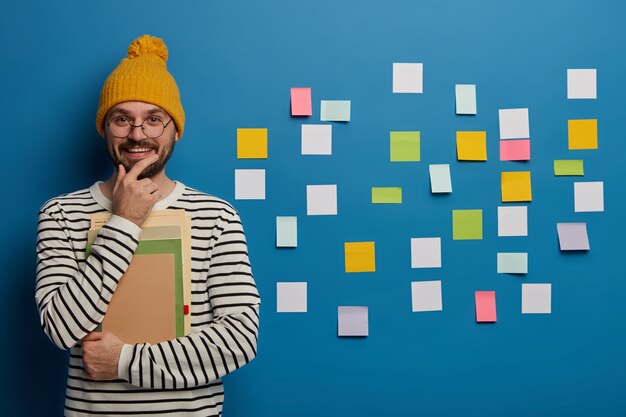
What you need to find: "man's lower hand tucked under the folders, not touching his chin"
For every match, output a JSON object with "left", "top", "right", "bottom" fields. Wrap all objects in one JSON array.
[{"left": 82, "top": 332, "right": 124, "bottom": 381}]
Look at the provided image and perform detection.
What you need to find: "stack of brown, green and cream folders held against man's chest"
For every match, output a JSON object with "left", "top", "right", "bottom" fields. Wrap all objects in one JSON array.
[{"left": 88, "top": 210, "right": 191, "bottom": 343}]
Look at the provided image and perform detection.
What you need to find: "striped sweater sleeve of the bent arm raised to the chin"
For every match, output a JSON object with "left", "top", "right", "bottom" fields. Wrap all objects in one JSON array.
[{"left": 35, "top": 206, "right": 141, "bottom": 349}]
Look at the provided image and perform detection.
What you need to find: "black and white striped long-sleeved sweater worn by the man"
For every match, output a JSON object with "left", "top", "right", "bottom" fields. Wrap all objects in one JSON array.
[{"left": 35, "top": 182, "right": 260, "bottom": 416}]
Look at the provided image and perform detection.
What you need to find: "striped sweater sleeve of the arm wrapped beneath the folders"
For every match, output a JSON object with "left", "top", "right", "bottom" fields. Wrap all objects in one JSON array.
[{"left": 118, "top": 210, "right": 260, "bottom": 389}]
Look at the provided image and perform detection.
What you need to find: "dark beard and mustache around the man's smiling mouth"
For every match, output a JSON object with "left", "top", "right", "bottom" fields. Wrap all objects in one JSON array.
[{"left": 105, "top": 134, "right": 176, "bottom": 180}]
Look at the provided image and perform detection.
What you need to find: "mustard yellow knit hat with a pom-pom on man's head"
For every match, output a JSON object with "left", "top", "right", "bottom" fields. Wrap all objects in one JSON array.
[{"left": 96, "top": 35, "right": 185, "bottom": 138}]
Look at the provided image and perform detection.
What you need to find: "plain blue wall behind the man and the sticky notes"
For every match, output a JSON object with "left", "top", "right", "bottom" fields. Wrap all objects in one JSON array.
[{"left": 0, "top": 0, "right": 626, "bottom": 417}]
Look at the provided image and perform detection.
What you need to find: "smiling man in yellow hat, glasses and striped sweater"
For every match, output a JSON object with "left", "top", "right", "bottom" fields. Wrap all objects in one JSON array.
[{"left": 35, "top": 35, "right": 260, "bottom": 416}]
